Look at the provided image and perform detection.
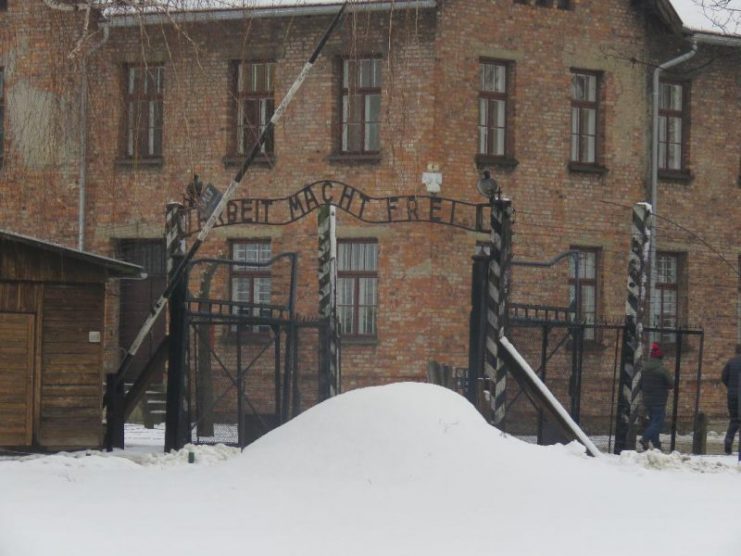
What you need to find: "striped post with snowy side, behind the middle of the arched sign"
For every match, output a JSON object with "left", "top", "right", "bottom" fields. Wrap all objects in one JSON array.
[{"left": 317, "top": 205, "right": 340, "bottom": 399}]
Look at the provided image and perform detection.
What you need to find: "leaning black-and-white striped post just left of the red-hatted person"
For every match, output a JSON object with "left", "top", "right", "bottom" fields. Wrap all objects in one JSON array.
[{"left": 615, "top": 203, "right": 652, "bottom": 454}]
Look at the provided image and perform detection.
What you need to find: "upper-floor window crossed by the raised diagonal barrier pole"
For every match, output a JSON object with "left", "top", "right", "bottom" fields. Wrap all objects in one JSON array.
[{"left": 234, "top": 62, "right": 275, "bottom": 159}]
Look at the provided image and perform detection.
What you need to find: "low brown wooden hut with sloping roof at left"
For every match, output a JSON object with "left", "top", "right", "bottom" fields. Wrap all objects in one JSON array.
[{"left": 0, "top": 230, "right": 141, "bottom": 449}]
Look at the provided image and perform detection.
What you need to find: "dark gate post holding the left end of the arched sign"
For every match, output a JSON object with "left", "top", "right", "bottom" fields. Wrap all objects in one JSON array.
[{"left": 165, "top": 203, "right": 188, "bottom": 452}]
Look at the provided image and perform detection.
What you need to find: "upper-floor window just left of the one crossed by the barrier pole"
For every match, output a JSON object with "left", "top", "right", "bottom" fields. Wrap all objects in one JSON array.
[{"left": 126, "top": 65, "right": 165, "bottom": 158}]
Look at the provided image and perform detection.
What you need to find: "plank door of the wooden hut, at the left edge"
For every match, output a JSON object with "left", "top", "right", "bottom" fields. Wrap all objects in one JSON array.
[{"left": 0, "top": 313, "right": 36, "bottom": 446}]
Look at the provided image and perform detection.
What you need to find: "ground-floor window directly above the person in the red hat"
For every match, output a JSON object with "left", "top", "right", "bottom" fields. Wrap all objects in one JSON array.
[{"left": 651, "top": 253, "right": 679, "bottom": 344}]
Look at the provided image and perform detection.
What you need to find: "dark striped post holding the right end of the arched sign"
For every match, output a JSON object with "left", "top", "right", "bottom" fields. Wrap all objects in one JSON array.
[{"left": 484, "top": 198, "right": 512, "bottom": 426}]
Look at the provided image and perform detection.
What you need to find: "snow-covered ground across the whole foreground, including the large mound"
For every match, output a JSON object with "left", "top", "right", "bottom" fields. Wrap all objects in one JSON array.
[{"left": 0, "top": 383, "right": 741, "bottom": 556}]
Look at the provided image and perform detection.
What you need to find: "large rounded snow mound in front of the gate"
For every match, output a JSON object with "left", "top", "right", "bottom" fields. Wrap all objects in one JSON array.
[{"left": 230, "top": 383, "right": 584, "bottom": 483}]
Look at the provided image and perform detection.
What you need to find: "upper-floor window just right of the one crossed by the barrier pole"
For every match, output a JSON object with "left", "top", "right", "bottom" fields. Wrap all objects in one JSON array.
[{"left": 340, "top": 58, "right": 381, "bottom": 154}]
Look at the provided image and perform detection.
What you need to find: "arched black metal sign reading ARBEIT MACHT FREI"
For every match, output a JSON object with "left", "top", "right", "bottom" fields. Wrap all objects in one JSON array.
[{"left": 185, "top": 180, "right": 490, "bottom": 235}]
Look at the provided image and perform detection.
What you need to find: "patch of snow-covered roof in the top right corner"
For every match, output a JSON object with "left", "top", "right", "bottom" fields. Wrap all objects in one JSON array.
[{"left": 671, "top": 0, "right": 741, "bottom": 36}]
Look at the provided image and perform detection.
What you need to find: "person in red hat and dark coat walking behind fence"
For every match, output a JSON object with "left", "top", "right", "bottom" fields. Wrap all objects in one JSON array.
[{"left": 640, "top": 342, "right": 674, "bottom": 450}]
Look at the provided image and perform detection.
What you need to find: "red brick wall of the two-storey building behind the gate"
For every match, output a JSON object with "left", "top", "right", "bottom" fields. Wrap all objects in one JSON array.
[{"left": 0, "top": 0, "right": 741, "bottom": 428}]
